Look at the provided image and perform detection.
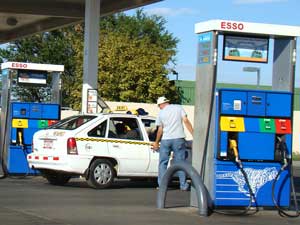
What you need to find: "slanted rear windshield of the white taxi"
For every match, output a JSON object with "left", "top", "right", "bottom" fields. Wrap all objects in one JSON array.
[{"left": 48, "top": 115, "right": 97, "bottom": 130}]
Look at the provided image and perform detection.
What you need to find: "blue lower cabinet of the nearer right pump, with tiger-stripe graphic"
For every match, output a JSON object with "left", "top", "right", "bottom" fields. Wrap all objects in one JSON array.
[{"left": 214, "top": 89, "right": 292, "bottom": 207}]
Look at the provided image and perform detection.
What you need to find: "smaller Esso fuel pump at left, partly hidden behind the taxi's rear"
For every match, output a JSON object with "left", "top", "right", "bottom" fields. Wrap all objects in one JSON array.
[{"left": 0, "top": 62, "right": 64, "bottom": 175}]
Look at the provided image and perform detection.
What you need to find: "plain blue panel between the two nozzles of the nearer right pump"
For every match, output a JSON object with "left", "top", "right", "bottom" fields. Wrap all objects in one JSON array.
[{"left": 238, "top": 132, "right": 275, "bottom": 160}]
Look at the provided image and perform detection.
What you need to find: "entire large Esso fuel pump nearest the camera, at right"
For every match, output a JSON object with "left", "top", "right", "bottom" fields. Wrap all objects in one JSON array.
[{"left": 191, "top": 20, "right": 300, "bottom": 216}]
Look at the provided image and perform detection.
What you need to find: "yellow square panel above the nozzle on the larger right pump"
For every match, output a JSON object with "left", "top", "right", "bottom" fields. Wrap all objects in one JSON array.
[{"left": 220, "top": 116, "right": 245, "bottom": 132}]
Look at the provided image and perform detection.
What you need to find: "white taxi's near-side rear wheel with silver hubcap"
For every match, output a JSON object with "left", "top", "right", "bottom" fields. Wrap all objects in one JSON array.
[{"left": 87, "top": 159, "right": 116, "bottom": 189}]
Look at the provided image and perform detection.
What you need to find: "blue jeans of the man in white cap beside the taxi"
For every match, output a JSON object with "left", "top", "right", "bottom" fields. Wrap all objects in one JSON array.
[{"left": 157, "top": 138, "right": 188, "bottom": 190}]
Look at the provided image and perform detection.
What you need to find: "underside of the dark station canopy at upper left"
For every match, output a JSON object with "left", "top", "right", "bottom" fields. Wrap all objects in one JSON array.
[{"left": 0, "top": 0, "right": 161, "bottom": 44}]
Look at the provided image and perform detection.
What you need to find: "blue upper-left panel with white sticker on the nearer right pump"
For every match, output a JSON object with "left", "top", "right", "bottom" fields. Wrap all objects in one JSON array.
[{"left": 220, "top": 90, "right": 247, "bottom": 115}]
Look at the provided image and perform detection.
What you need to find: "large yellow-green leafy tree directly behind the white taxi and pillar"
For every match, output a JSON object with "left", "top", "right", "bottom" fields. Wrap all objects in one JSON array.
[{"left": 72, "top": 10, "right": 180, "bottom": 107}]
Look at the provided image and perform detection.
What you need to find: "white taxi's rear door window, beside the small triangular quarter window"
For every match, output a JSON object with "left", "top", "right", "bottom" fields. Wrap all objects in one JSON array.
[{"left": 109, "top": 117, "right": 143, "bottom": 140}]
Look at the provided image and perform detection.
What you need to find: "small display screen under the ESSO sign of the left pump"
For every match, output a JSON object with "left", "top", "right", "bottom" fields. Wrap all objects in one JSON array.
[{"left": 18, "top": 70, "right": 47, "bottom": 86}]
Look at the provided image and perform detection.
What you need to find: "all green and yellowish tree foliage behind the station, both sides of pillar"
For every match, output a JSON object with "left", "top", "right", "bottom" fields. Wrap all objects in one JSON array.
[{"left": 0, "top": 10, "right": 179, "bottom": 109}]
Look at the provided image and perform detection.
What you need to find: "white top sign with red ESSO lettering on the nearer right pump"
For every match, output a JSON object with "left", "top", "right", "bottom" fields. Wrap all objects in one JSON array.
[{"left": 195, "top": 20, "right": 300, "bottom": 37}]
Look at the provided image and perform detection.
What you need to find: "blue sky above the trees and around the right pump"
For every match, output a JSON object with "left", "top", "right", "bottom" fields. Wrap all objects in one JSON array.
[{"left": 130, "top": 0, "right": 300, "bottom": 86}]
